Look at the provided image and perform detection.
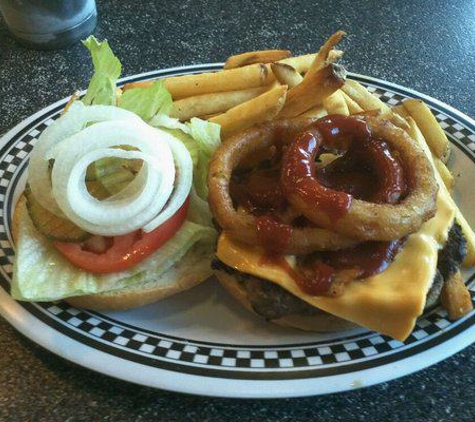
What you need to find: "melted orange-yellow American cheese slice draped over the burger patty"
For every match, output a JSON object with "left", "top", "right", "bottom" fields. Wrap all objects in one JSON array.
[{"left": 216, "top": 188, "right": 456, "bottom": 341}]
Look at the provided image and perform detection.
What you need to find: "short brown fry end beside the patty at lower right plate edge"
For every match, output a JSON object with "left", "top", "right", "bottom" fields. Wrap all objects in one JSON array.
[{"left": 440, "top": 271, "right": 473, "bottom": 319}]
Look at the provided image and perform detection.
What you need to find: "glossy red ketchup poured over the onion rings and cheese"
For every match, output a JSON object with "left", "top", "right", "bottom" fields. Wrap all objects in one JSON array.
[{"left": 236, "top": 115, "right": 407, "bottom": 296}]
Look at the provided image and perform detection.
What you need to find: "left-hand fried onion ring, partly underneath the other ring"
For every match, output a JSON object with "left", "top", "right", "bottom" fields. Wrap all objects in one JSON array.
[{"left": 208, "top": 118, "right": 358, "bottom": 254}]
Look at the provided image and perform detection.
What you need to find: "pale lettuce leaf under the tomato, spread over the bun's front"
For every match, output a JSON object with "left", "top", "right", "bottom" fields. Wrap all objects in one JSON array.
[{"left": 11, "top": 205, "right": 216, "bottom": 301}]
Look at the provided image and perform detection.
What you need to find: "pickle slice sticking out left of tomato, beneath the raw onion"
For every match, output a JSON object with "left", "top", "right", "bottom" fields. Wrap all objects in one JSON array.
[{"left": 25, "top": 186, "right": 91, "bottom": 242}]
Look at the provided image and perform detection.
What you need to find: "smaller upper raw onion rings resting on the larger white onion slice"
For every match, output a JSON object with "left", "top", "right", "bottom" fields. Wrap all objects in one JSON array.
[{"left": 46, "top": 121, "right": 192, "bottom": 236}]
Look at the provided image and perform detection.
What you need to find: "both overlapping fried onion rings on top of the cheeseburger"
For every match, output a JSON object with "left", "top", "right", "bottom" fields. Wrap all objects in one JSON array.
[{"left": 208, "top": 116, "right": 438, "bottom": 254}]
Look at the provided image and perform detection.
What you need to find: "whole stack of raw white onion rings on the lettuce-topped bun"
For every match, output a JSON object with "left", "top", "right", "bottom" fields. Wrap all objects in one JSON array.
[{"left": 29, "top": 105, "right": 193, "bottom": 236}]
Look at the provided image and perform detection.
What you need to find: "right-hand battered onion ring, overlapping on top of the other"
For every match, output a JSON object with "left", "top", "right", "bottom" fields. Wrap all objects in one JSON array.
[{"left": 281, "top": 117, "right": 438, "bottom": 241}]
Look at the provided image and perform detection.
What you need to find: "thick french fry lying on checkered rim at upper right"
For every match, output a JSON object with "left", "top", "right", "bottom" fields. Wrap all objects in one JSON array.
[{"left": 403, "top": 99, "right": 450, "bottom": 163}]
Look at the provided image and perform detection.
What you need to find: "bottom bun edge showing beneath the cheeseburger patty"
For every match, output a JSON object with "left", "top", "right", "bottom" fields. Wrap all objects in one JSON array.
[{"left": 214, "top": 271, "right": 358, "bottom": 332}]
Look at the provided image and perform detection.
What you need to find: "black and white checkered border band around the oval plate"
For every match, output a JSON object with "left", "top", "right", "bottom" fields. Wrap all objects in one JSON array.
[{"left": 0, "top": 65, "right": 475, "bottom": 394}]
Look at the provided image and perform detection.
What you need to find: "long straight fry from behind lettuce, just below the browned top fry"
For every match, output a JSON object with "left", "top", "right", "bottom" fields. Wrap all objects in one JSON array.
[{"left": 124, "top": 64, "right": 275, "bottom": 100}]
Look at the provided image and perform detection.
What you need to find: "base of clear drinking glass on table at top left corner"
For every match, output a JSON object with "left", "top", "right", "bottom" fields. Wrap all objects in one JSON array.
[{"left": 0, "top": 0, "right": 97, "bottom": 50}]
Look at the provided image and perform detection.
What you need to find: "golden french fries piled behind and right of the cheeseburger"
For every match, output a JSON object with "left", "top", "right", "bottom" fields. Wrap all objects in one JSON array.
[{"left": 124, "top": 31, "right": 475, "bottom": 318}]
